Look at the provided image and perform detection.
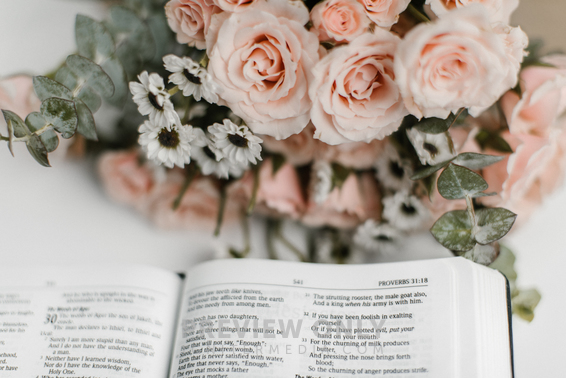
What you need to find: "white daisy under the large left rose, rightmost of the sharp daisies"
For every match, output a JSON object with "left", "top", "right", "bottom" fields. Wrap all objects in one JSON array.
[{"left": 208, "top": 118, "right": 263, "bottom": 166}]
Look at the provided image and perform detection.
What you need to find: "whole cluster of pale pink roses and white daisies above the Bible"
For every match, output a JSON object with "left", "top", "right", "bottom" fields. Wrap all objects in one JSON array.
[{"left": 93, "top": 0, "right": 566, "bottom": 254}]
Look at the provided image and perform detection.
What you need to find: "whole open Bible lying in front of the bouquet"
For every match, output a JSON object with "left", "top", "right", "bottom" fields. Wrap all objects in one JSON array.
[{"left": 0, "top": 258, "right": 513, "bottom": 378}]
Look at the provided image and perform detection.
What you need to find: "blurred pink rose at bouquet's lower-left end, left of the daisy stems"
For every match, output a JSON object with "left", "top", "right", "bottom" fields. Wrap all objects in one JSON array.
[{"left": 98, "top": 150, "right": 155, "bottom": 206}]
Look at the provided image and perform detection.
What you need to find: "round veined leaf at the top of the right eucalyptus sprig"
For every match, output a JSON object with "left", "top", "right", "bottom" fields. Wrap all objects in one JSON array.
[{"left": 438, "top": 163, "right": 487, "bottom": 199}]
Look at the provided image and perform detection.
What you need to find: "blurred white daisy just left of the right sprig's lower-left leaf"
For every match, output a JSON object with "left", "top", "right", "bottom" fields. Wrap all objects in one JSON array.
[{"left": 382, "top": 191, "right": 430, "bottom": 231}]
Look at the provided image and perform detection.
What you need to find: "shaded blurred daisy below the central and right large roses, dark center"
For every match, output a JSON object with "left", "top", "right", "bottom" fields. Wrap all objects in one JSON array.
[{"left": 374, "top": 144, "right": 413, "bottom": 191}]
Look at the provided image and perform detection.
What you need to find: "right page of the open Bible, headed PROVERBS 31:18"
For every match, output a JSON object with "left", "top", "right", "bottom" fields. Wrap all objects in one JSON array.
[{"left": 170, "top": 259, "right": 462, "bottom": 378}]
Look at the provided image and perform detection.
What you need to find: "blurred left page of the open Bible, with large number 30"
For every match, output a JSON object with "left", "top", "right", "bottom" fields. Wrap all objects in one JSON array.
[{"left": 0, "top": 267, "right": 182, "bottom": 378}]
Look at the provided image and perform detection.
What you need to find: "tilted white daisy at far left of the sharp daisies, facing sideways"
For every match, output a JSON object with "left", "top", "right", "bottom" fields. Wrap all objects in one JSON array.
[{"left": 130, "top": 71, "right": 181, "bottom": 126}]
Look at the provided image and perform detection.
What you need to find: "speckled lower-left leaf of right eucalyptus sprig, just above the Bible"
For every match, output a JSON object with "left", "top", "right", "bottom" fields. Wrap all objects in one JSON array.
[{"left": 430, "top": 210, "right": 476, "bottom": 252}]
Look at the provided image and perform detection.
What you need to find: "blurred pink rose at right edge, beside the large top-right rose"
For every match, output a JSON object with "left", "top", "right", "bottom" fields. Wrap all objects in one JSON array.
[{"left": 501, "top": 55, "right": 566, "bottom": 137}]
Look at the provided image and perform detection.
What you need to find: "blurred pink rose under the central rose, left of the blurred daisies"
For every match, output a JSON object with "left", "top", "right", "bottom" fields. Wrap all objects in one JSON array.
[{"left": 301, "top": 172, "right": 381, "bottom": 229}]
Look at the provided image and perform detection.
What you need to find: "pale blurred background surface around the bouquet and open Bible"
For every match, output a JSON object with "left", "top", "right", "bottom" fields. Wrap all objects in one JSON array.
[{"left": 0, "top": 0, "right": 566, "bottom": 378}]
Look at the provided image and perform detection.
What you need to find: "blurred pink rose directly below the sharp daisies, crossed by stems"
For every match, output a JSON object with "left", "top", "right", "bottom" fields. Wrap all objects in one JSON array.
[{"left": 139, "top": 170, "right": 241, "bottom": 230}]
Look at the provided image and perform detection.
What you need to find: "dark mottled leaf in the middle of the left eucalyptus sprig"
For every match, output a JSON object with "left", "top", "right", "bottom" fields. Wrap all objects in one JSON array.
[{"left": 40, "top": 97, "right": 78, "bottom": 139}]
